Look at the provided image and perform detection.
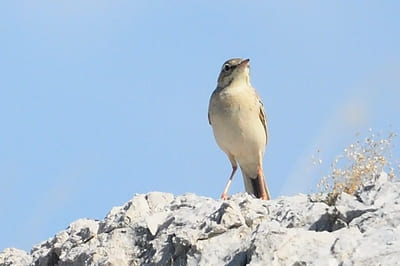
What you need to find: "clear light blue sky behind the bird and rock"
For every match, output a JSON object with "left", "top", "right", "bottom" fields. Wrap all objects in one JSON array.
[{"left": 0, "top": 0, "right": 400, "bottom": 250}]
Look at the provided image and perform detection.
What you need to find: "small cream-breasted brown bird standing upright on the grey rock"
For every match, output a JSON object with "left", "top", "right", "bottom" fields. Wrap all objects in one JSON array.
[{"left": 208, "top": 58, "right": 271, "bottom": 200}]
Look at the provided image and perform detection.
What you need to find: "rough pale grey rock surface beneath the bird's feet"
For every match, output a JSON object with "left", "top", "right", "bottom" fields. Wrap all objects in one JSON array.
[{"left": 0, "top": 173, "right": 400, "bottom": 266}]
